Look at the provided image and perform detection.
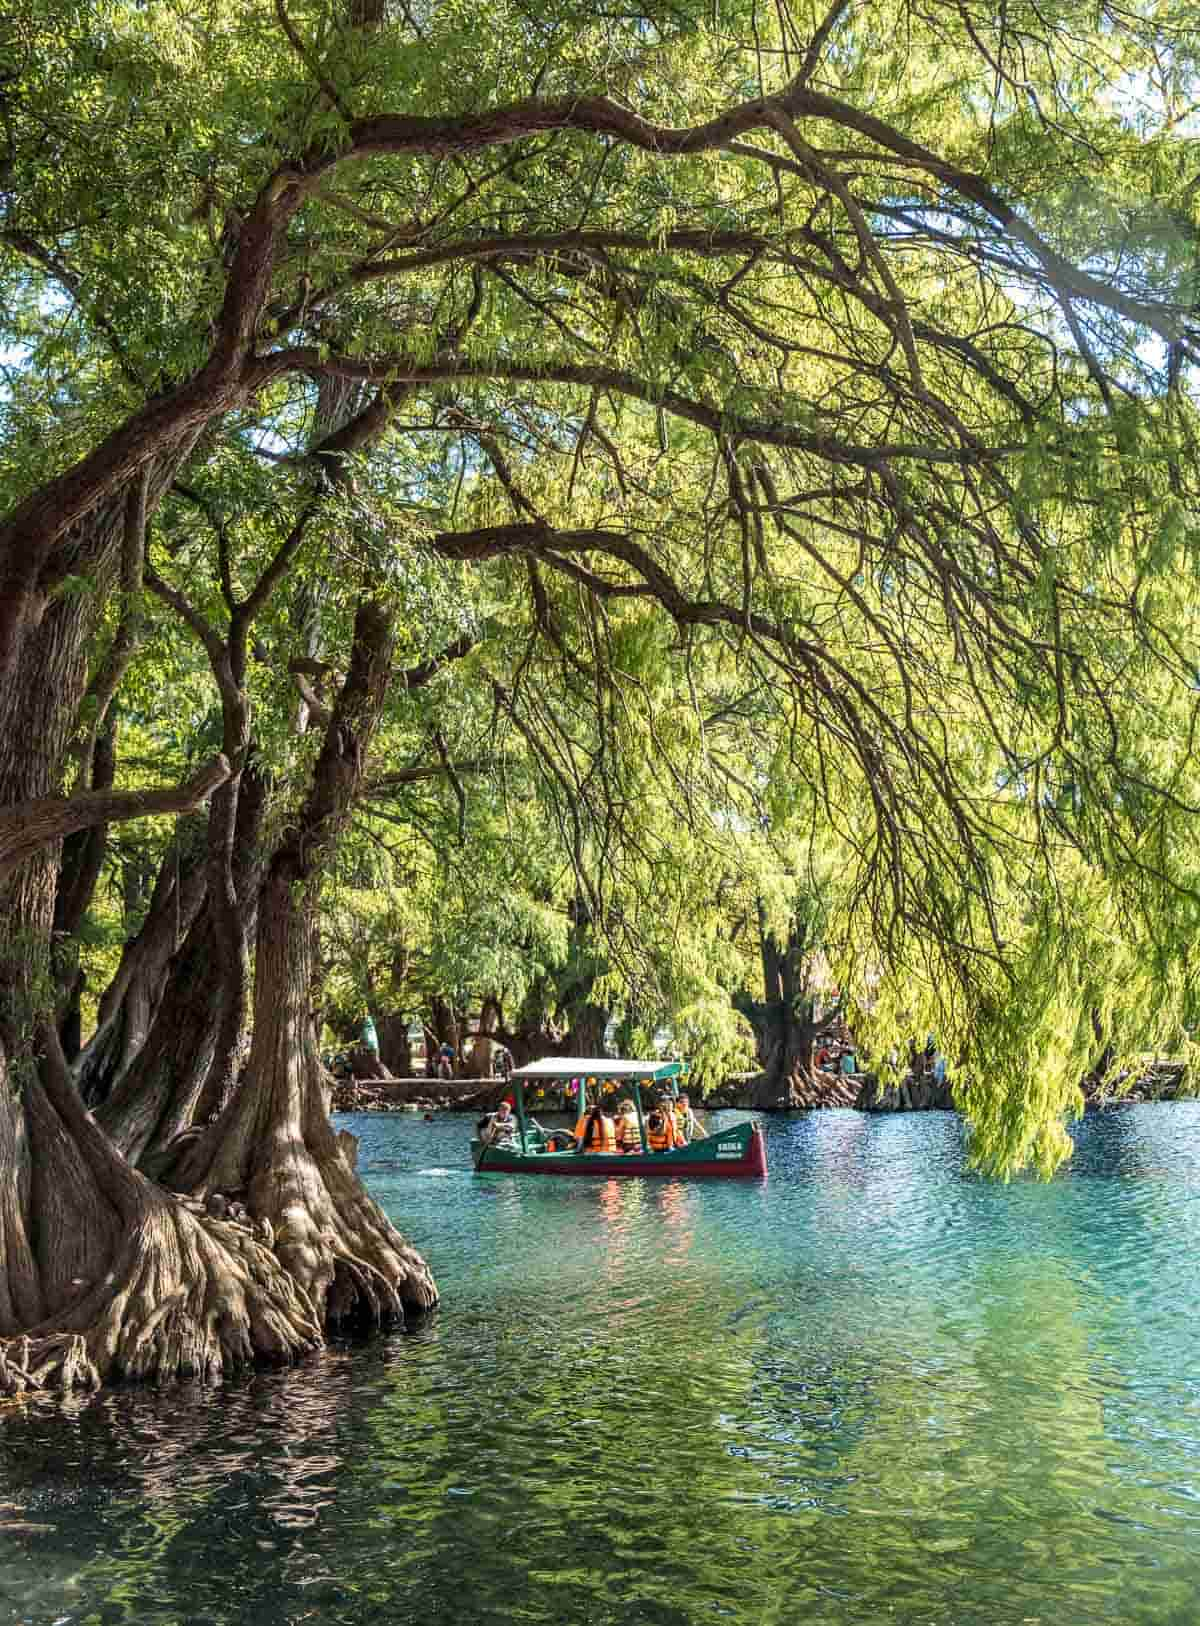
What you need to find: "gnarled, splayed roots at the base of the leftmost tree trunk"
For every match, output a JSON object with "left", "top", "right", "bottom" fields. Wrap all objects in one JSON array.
[{"left": 0, "top": 1193, "right": 324, "bottom": 1393}]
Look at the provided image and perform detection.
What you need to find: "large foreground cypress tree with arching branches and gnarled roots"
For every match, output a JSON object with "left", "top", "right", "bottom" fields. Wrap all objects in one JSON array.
[{"left": 0, "top": 0, "right": 1197, "bottom": 1384}]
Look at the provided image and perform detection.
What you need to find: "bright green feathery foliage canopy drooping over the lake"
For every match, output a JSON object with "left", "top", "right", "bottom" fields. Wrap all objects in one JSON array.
[{"left": 0, "top": 0, "right": 1200, "bottom": 1174}]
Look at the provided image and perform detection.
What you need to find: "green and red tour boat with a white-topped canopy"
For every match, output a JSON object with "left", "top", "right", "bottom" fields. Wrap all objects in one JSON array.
[{"left": 472, "top": 1055, "right": 766, "bottom": 1179}]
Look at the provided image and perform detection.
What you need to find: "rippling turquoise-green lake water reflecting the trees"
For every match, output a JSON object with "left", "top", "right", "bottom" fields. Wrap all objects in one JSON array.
[{"left": 0, "top": 1104, "right": 1200, "bottom": 1626}]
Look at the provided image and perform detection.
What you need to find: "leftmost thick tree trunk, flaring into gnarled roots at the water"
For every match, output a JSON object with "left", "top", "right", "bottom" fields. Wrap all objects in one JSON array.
[{"left": 0, "top": 554, "right": 320, "bottom": 1392}]
